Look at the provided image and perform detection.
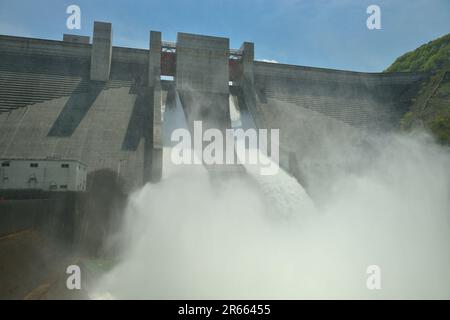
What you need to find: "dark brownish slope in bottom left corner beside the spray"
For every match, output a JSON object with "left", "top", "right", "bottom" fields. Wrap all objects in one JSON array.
[{"left": 0, "top": 230, "right": 88, "bottom": 300}]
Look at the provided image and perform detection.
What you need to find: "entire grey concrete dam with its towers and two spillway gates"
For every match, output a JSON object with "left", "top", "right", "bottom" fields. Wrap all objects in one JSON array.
[{"left": 0, "top": 22, "right": 436, "bottom": 296}]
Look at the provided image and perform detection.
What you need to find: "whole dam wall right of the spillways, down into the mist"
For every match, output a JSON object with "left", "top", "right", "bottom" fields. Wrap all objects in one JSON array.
[{"left": 249, "top": 61, "right": 427, "bottom": 193}]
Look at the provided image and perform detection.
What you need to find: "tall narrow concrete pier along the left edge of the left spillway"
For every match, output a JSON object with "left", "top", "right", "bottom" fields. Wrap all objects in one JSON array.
[{"left": 148, "top": 31, "right": 163, "bottom": 182}]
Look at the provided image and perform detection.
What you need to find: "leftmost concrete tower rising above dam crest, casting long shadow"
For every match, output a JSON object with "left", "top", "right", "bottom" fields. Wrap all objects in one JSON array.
[{"left": 91, "top": 21, "right": 112, "bottom": 81}]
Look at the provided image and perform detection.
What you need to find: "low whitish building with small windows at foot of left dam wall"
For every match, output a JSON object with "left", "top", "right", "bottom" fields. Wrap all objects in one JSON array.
[{"left": 0, "top": 159, "right": 87, "bottom": 191}]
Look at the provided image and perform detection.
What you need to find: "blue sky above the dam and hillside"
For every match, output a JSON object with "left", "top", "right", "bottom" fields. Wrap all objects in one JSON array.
[{"left": 0, "top": 0, "right": 450, "bottom": 72}]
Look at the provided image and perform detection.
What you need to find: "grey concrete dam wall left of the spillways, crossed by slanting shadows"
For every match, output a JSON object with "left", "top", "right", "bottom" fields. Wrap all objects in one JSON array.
[{"left": 0, "top": 27, "right": 152, "bottom": 192}]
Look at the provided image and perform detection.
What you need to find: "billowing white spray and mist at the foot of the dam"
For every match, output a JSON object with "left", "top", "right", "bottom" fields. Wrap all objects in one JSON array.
[{"left": 92, "top": 124, "right": 450, "bottom": 299}]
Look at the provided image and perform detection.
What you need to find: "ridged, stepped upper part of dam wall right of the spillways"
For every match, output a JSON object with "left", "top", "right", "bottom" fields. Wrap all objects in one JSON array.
[{"left": 253, "top": 62, "right": 425, "bottom": 130}]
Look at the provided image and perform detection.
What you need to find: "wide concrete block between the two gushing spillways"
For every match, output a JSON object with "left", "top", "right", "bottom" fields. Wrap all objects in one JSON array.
[{"left": 175, "top": 33, "right": 230, "bottom": 129}]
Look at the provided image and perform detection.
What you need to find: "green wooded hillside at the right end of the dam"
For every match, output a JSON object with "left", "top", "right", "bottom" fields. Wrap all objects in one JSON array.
[{"left": 385, "top": 34, "right": 450, "bottom": 145}]
